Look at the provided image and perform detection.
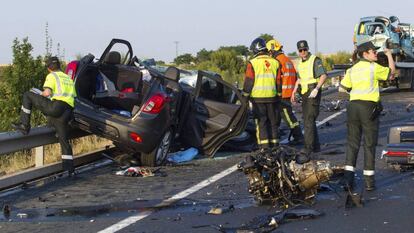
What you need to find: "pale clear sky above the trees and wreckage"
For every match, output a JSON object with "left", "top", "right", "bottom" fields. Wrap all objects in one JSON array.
[{"left": 0, "top": 0, "right": 414, "bottom": 64}]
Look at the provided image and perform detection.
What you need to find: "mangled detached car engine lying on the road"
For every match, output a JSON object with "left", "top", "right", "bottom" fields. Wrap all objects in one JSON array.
[{"left": 239, "top": 146, "right": 333, "bottom": 207}]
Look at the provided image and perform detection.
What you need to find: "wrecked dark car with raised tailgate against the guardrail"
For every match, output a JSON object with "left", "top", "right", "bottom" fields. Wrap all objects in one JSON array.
[{"left": 66, "top": 39, "right": 248, "bottom": 166}]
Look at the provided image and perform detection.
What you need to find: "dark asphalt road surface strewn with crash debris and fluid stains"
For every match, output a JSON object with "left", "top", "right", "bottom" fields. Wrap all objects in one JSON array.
[{"left": 0, "top": 88, "right": 414, "bottom": 233}]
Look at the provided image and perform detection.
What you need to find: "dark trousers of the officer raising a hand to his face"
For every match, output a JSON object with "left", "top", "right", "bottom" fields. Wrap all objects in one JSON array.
[{"left": 345, "top": 100, "right": 379, "bottom": 171}]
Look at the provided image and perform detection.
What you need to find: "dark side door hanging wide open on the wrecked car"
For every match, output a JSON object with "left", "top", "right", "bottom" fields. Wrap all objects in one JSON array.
[{"left": 181, "top": 71, "right": 248, "bottom": 156}]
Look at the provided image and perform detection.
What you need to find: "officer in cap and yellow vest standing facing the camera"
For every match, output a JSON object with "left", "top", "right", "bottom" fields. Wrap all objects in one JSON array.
[{"left": 291, "top": 40, "right": 327, "bottom": 160}]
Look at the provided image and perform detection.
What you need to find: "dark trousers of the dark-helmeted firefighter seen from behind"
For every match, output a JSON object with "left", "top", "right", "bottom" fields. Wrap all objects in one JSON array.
[{"left": 252, "top": 101, "right": 279, "bottom": 149}]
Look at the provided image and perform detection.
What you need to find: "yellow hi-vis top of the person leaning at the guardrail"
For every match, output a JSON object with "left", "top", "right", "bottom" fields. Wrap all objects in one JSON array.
[{"left": 43, "top": 71, "right": 76, "bottom": 107}]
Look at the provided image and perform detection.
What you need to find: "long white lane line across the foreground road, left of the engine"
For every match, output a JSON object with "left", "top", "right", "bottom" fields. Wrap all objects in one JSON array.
[{"left": 98, "top": 164, "right": 237, "bottom": 233}]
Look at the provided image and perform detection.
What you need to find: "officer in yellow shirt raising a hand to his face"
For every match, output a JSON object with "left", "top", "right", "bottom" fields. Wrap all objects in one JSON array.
[{"left": 340, "top": 42, "right": 395, "bottom": 191}]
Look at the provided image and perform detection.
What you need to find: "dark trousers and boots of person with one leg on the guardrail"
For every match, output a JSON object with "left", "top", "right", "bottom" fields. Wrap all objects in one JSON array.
[{"left": 20, "top": 91, "right": 74, "bottom": 172}]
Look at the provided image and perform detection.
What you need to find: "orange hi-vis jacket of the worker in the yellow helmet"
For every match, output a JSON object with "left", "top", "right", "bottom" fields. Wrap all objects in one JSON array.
[{"left": 276, "top": 53, "right": 296, "bottom": 98}]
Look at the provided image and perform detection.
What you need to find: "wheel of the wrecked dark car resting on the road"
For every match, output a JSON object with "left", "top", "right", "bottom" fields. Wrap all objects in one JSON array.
[{"left": 141, "top": 129, "right": 173, "bottom": 167}]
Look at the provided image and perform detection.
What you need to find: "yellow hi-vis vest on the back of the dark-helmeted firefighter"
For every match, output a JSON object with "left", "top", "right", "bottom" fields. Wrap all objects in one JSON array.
[{"left": 250, "top": 55, "right": 279, "bottom": 98}]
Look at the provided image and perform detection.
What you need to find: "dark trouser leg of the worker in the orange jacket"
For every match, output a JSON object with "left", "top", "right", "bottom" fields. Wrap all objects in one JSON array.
[{"left": 278, "top": 99, "right": 303, "bottom": 140}]
